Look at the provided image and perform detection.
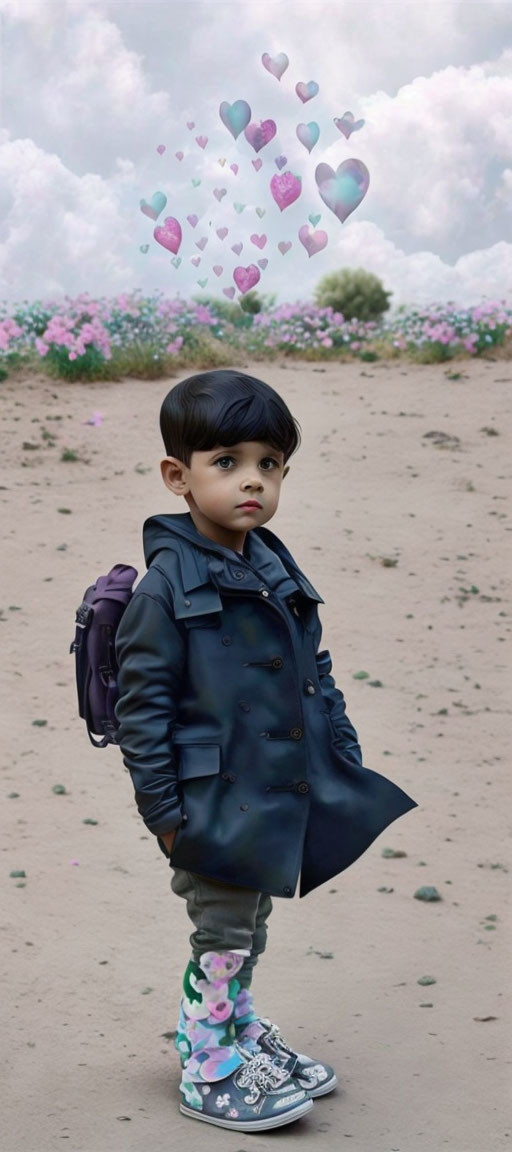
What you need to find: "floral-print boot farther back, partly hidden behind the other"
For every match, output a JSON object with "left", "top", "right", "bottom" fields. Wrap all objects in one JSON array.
[{"left": 234, "top": 988, "right": 338, "bottom": 1097}]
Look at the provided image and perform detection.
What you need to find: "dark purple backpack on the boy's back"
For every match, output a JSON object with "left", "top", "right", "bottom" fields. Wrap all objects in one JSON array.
[{"left": 69, "top": 564, "right": 137, "bottom": 748}]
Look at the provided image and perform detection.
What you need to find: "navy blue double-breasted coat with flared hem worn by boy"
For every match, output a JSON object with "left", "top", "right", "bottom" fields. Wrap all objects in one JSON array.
[{"left": 115, "top": 513, "right": 417, "bottom": 897}]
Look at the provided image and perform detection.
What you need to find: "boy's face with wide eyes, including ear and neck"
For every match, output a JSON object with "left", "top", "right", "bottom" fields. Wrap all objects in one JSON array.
[{"left": 160, "top": 440, "right": 289, "bottom": 552}]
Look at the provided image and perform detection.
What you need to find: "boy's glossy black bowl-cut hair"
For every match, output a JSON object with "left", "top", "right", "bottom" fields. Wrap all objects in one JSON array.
[{"left": 160, "top": 369, "right": 301, "bottom": 468}]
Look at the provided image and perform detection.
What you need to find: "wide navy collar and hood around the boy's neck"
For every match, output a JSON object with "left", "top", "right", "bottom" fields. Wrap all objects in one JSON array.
[{"left": 143, "top": 513, "right": 324, "bottom": 604}]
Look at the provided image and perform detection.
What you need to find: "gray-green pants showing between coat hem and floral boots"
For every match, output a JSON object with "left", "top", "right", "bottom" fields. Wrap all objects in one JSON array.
[{"left": 171, "top": 867, "right": 272, "bottom": 988}]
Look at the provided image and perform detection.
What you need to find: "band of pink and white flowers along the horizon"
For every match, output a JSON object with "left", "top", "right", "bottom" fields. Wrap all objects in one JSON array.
[{"left": 0, "top": 291, "right": 512, "bottom": 380}]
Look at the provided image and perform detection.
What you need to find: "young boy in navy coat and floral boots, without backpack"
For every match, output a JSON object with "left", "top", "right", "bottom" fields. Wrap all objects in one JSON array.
[{"left": 116, "top": 370, "right": 416, "bottom": 1131}]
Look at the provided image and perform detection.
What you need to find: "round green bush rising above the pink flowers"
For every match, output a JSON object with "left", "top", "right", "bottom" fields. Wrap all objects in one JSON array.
[{"left": 315, "top": 268, "right": 393, "bottom": 320}]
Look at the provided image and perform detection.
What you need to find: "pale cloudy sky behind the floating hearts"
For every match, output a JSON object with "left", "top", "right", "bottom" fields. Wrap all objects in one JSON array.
[{"left": 0, "top": 0, "right": 512, "bottom": 306}]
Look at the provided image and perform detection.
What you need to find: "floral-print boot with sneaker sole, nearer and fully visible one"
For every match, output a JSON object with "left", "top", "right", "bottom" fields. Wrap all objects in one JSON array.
[{"left": 174, "top": 952, "right": 313, "bottom": 1132}]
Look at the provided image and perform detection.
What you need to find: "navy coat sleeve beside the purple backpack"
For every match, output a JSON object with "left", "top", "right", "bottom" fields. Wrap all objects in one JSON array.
[{"left": 115, "top": 592, "right": 185, "bottom": 836}]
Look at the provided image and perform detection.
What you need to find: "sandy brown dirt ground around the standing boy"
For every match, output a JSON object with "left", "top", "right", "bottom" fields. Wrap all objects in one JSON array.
[{"left": 0, "top": 359, "right": 512, "bottom": 1152}]
